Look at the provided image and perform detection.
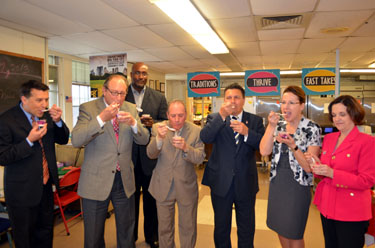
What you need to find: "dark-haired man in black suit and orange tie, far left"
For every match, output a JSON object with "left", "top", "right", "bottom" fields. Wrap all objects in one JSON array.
[{"left": 0, "top": 80, "right": 69, "bottom": 248}]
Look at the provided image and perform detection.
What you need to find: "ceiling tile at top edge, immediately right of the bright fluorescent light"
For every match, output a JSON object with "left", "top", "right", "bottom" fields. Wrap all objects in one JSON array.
[{"left": 193, "top": 0, "right": 250, "bottom": 19}]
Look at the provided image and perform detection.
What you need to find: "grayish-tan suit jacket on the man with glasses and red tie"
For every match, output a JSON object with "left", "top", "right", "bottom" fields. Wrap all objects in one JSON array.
[{"left": 72, "top": 97, "right": 149, "bottom": 201}]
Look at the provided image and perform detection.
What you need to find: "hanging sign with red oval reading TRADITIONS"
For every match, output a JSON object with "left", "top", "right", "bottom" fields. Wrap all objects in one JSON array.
[{"left": 187, "top": 71, "right": 220, "bottom": 97}]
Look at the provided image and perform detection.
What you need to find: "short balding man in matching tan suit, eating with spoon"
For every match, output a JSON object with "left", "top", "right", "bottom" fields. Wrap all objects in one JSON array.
[{"left": 147, "top": 100, "right": 205, "bottom": 248}]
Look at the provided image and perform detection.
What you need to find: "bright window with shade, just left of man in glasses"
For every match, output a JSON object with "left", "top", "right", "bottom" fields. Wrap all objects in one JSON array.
[{"left": 72, "top": 61, "right": 90, "bottom": 126}]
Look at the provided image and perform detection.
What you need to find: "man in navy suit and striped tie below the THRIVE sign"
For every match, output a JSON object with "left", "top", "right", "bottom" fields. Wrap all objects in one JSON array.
[{"left": 201, "top": 84, "right": 264, "bottom": 248}]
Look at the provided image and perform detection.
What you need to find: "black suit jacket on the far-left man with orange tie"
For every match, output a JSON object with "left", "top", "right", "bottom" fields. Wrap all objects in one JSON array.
[{"left": 0, "top": 105, "right": 69, "bottom": 207}]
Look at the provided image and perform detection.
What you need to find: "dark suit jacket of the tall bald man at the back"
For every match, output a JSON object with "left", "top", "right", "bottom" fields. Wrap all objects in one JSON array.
[{"left": 125, "top": 87, "right": 168, "bottom": 176}]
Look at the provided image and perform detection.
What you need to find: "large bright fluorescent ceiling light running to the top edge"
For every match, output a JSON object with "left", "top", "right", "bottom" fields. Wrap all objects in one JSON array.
[{"left": 149, "top": 0, "right": 229, "bottom": 54}]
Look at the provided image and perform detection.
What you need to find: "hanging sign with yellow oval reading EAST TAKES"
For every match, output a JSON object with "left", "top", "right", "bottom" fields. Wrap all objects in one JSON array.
[{"left": 302, "top": 68, "right": 336, "bottom": 95}]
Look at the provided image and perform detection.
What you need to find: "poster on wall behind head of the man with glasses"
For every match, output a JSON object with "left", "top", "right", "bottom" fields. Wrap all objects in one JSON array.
[{"left": 90, "top": 53, "right": 128, "bottom": 98}]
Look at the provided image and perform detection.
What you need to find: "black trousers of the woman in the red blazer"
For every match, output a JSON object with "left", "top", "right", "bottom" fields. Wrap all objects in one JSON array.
[{"left": 320, "top": 215, "right": 369, "bottom": 248}]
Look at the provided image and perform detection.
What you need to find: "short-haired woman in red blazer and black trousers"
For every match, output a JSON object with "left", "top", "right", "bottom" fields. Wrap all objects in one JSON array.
[{"left": 307, "top": 95, "right": 375, "bottom": 248}]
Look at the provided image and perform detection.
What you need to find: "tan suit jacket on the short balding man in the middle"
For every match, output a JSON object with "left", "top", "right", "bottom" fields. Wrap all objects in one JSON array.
[{"left": 147, "top": 122, "right": 205, "bottom": 204}]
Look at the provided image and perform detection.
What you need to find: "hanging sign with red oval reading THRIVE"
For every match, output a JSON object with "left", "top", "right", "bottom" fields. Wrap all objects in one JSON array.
[{"left": 245, "top": 70, "right": 280, "bottom": 96}]
